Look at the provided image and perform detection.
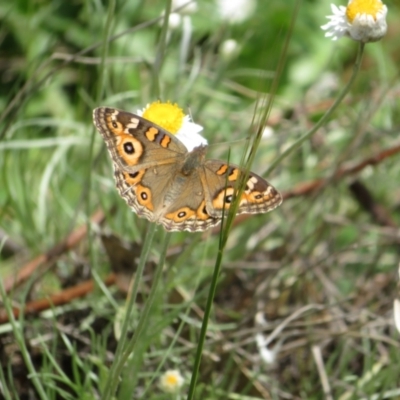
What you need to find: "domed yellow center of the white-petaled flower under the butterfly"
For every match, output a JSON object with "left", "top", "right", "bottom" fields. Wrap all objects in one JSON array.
[{"left": 143, "top": 100, "right": 185, "bottom": 134}]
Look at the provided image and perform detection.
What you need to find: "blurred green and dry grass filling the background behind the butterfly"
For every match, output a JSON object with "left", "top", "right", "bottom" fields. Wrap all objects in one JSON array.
[{"left": 0, "top": 0, "right": 400, "bottom": 400}]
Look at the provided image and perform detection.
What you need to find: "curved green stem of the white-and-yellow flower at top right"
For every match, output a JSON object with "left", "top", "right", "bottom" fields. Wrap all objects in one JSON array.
[{"left": 265, "top": 43, "right": 364, "bottom": 176}]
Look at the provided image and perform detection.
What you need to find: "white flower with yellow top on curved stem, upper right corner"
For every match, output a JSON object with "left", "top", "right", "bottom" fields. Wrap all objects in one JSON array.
[{"left": 321, "top": 0, "right": 387, "bottom": 43}]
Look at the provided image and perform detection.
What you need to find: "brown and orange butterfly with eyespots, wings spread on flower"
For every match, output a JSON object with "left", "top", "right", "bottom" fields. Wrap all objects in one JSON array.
[{"left": 93, "top": 107, "right": 282, "bottom": 232}]
